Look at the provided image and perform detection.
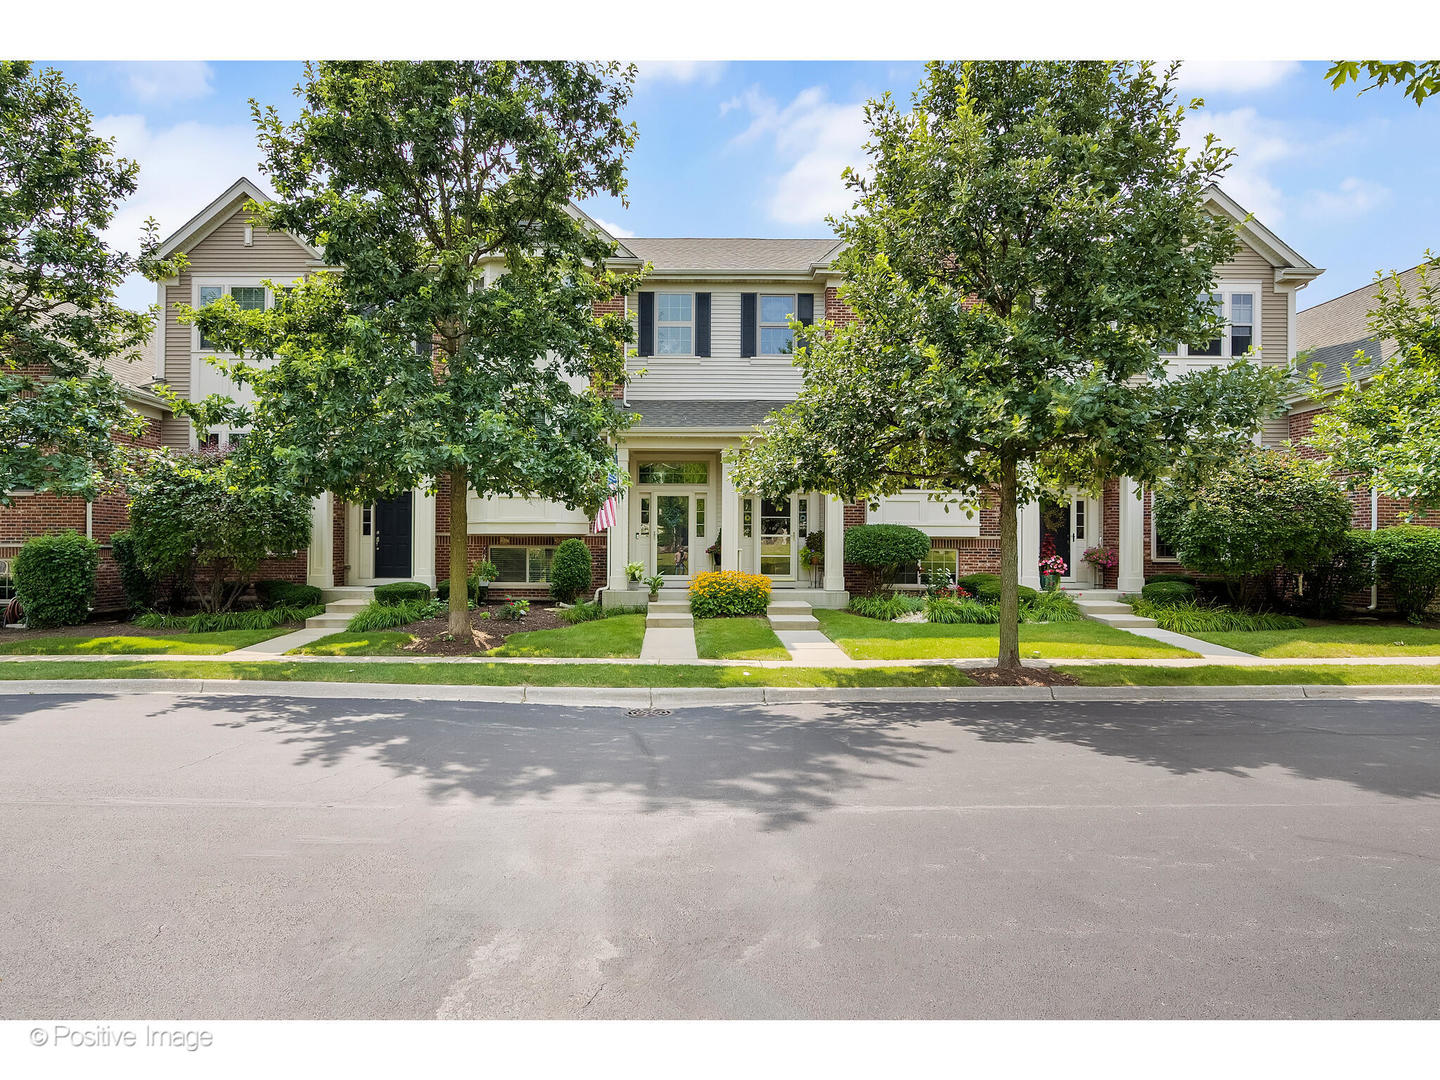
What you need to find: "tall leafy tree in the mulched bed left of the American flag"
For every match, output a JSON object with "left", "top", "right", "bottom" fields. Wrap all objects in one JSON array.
[{"left": 192, "top": 62, "right": 639, "bottom": 635}]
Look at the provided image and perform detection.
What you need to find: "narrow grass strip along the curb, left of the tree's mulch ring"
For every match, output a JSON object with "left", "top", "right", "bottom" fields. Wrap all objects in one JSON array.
[{"left": 0, "top": 660, "right": 973, "bottom": 687}]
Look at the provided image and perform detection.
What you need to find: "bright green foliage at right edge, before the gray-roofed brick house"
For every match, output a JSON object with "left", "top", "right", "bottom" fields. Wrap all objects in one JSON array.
[{"left": 1308, "top": 262, "right": 1440, "bottom": 510}]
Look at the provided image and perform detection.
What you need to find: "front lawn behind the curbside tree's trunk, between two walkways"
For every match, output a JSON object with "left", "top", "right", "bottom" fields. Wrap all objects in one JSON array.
[{"left": 815, "top": 609, "right": 1197, "bottom": 660}]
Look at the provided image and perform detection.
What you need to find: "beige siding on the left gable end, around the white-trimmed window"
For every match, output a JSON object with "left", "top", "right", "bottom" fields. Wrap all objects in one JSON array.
[{"left": 160, "top": 202, "right": 320, "bottom": 449}]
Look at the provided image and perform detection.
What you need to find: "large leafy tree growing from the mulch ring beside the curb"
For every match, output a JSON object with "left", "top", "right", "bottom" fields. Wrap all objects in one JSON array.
[{"left": 736, "top": 63, "right": 1280, "bottom": 668}]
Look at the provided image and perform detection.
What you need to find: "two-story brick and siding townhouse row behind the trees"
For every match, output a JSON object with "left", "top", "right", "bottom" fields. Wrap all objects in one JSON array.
[{"left": 92, "top": 179, "right": 1322, "bottom": 606}]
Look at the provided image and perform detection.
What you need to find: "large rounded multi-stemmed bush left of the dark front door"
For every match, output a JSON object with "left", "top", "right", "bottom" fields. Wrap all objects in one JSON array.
[{"left": 130, "top": 454, "right": 310, "bottom": 612}]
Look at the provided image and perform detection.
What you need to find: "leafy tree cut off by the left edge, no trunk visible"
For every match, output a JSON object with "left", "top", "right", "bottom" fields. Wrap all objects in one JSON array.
[{"left": 0, "top": 60, "right": 183, "bottom": 505}]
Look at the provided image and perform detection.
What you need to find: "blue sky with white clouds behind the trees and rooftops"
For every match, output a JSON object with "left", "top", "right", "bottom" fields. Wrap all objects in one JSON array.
[{"left": 46, "top": 60, "right": 1440, "bottom": 308}]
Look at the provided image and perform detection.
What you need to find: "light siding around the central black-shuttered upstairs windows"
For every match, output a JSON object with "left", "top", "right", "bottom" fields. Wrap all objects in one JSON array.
[{"left": 628, "top": 281, "right": 825, "bottom": 402}]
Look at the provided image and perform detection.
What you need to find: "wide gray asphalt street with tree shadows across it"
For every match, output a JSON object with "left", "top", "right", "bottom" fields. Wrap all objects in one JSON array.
[{"left": 0, "top": 690, "right": 1440, "bottom": 1020}]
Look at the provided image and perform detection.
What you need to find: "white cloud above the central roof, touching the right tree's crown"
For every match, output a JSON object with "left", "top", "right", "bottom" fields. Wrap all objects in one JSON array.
[{"left": 720, "top": 86, "right": 867, "bottom": 225}]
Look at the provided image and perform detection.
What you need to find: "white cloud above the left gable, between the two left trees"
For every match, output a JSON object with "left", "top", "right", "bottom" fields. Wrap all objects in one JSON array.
[{"left": 95, "top": 115, "right": 261, "bottom": 308}]
